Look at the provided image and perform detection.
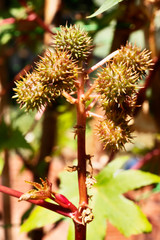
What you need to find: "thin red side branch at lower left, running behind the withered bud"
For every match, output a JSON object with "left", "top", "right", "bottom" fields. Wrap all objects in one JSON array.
[{"left": 0, "top": 185, "right": 72, "bottom": 217}]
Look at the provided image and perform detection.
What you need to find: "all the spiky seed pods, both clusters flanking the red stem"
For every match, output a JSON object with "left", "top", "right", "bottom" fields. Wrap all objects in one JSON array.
[{"left": 14, "top": 25, "right": 152, "bottom": 150}]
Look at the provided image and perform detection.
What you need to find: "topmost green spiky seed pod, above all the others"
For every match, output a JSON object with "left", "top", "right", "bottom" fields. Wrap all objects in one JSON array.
[{"left": 53, "top": 25, "right": 93, "bottom": 61}]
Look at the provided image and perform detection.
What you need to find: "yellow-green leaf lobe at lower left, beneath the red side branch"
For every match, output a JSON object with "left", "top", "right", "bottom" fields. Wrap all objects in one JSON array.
[{"left": 21, "top": 206, "right": 63, "bottom": 232}]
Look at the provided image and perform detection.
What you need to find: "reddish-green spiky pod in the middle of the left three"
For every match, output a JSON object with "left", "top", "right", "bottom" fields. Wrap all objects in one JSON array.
[{"left": 36, "top": 50, "right": 79, "bottom": 93}]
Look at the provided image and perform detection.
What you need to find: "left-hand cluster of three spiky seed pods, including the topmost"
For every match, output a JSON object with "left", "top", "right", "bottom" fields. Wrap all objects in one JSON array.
[{"left": 14, "top": 25, "right": 92, "bottom": 111}]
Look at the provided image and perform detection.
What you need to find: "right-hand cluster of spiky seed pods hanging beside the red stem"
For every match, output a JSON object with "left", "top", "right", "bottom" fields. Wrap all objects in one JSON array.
[{"left": 97, "top": 44, "right": 152, "bottom": 151}]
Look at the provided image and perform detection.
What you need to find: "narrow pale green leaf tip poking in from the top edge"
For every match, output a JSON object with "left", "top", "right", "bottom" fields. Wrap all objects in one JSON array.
[{"left": 87, "top": 0, "right": 123, "bottom": 18}]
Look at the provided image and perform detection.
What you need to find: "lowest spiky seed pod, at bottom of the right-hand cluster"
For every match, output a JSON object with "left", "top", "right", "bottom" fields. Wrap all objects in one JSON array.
[{"left": 96, "top": 119, "right": 132, "bottom": 151}]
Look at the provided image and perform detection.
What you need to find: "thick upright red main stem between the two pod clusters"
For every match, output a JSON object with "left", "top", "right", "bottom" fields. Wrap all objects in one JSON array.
[{"left": 75, "top": 71, "right": 88, "bottom": 240}]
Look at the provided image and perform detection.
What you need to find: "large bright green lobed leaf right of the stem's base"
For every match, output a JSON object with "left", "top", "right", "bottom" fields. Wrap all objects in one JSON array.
[{"left": 93, "top": 158, "right": 160, "bottom": 239}]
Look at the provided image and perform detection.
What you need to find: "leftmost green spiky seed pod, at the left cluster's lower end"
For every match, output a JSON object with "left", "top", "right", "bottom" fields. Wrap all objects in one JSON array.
[{"left": 13, "top": 71, "right": 51, "bottom": 111}]
